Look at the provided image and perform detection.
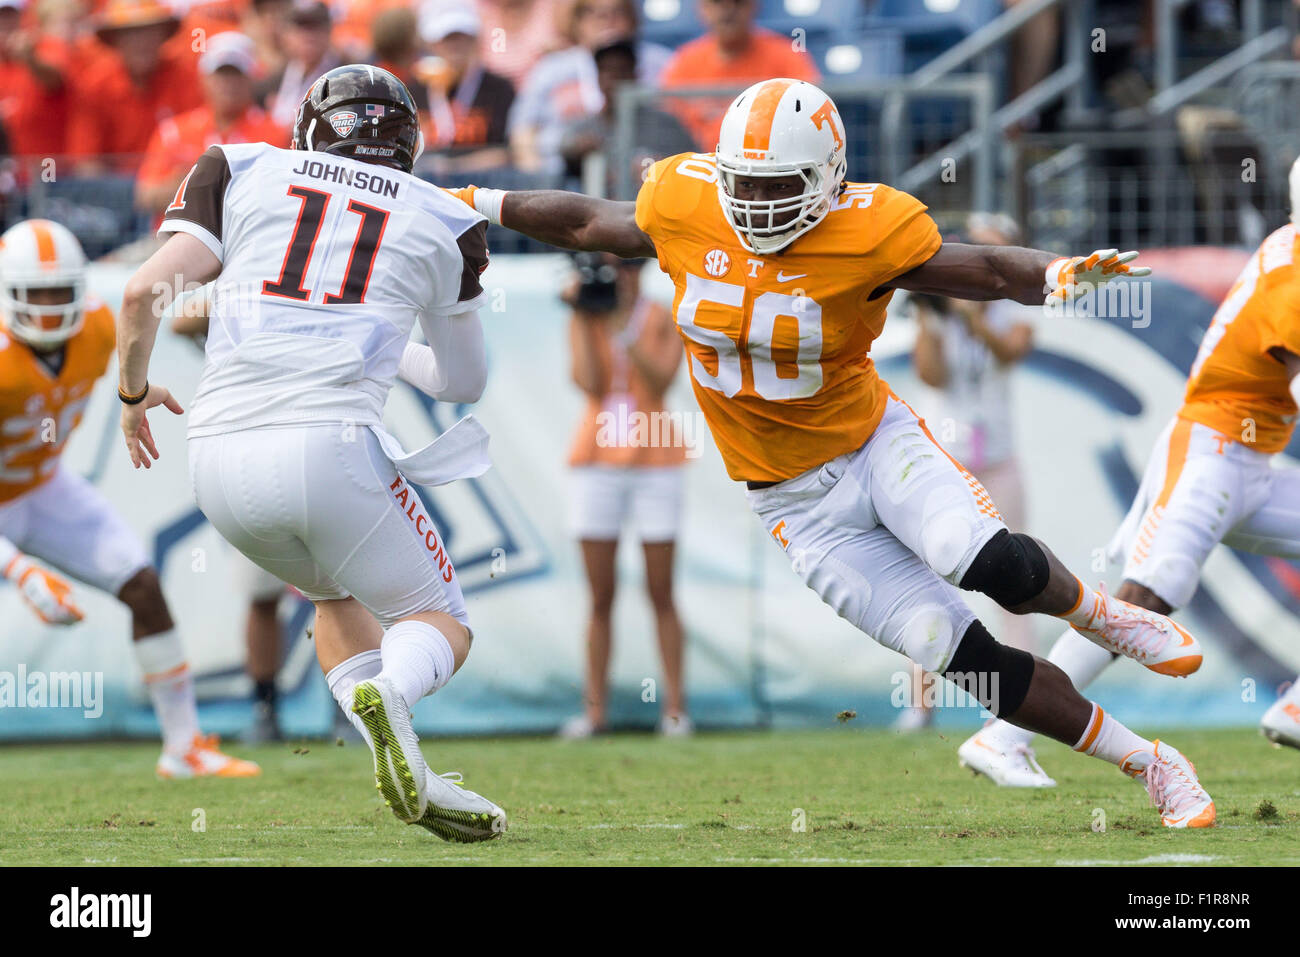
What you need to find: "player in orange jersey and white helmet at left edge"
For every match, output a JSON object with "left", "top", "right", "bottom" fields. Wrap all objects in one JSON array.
[{"left": 0, "top": 220, "right": 259, "bottom": 778}]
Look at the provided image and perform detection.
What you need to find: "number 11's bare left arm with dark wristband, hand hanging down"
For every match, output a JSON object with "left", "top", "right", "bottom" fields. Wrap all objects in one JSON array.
[{"left": 117, "top": 233, "right": 221, "bottom": 468}]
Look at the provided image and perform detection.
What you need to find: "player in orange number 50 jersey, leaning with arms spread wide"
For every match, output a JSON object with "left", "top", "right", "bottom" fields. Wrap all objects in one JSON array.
[{"left": 456, "top": 79, "right": 1214, "bottom": 827}]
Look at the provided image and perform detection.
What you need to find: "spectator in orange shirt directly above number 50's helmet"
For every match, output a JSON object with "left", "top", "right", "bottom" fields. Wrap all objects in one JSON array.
[{"left": 659, "top": 0, "right": 819, "bottom": 151}]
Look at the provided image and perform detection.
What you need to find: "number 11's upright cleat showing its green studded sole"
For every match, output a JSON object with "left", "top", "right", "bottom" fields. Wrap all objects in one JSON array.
[{"left": 352, "top": 677, "right": 429, "bottom": 824}]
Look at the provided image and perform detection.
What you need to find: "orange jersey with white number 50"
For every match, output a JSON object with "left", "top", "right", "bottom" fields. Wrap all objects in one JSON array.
[{"left": 636, "top": 153, "right": 943, "bottom": 481}]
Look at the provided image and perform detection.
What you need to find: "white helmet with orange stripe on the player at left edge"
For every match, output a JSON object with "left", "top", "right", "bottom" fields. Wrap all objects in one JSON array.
[{"left": 0, "top": 220, "right": 86, "bottom": 348}]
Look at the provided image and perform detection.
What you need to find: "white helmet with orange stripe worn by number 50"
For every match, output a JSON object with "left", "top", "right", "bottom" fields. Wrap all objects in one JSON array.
[{"left": 716, "top": 79, "right": 848, "bottom": 255}]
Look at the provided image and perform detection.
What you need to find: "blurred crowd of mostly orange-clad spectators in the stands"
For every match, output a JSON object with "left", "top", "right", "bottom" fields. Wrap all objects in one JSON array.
[{"left": 0, "top": 0, "right": 818, "bottom": 243}]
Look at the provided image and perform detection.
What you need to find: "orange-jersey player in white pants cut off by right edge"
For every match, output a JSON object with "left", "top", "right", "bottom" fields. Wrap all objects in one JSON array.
[{"left": 958, "top": 160, "right": 1300, "bottom": 787}]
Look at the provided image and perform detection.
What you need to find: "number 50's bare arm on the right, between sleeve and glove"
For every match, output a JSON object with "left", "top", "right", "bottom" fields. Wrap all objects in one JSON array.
[{"left": 888, "top": 243, "right": 1057, "bottom": 306}]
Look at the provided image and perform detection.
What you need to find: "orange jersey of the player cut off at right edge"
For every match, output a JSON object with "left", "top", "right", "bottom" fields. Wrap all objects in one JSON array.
[{"left": 1179, "top": 225, "right": 1300, "bottom": 452}]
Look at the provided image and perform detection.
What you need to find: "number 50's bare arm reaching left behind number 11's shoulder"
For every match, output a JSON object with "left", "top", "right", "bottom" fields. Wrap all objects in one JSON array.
[{"left": 501, "top": 190, "right": 655, "bottom": 259}]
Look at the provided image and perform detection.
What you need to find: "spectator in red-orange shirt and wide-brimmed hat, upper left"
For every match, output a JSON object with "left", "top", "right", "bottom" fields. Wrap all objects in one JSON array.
[{"left": 68, "top": 0, "right": 203, "bottom": 174}]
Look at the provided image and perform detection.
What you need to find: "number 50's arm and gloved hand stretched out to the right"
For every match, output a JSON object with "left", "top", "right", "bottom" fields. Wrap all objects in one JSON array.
[{"left": 885, "top": 243, "right": 1151, "bottom": 306}]
